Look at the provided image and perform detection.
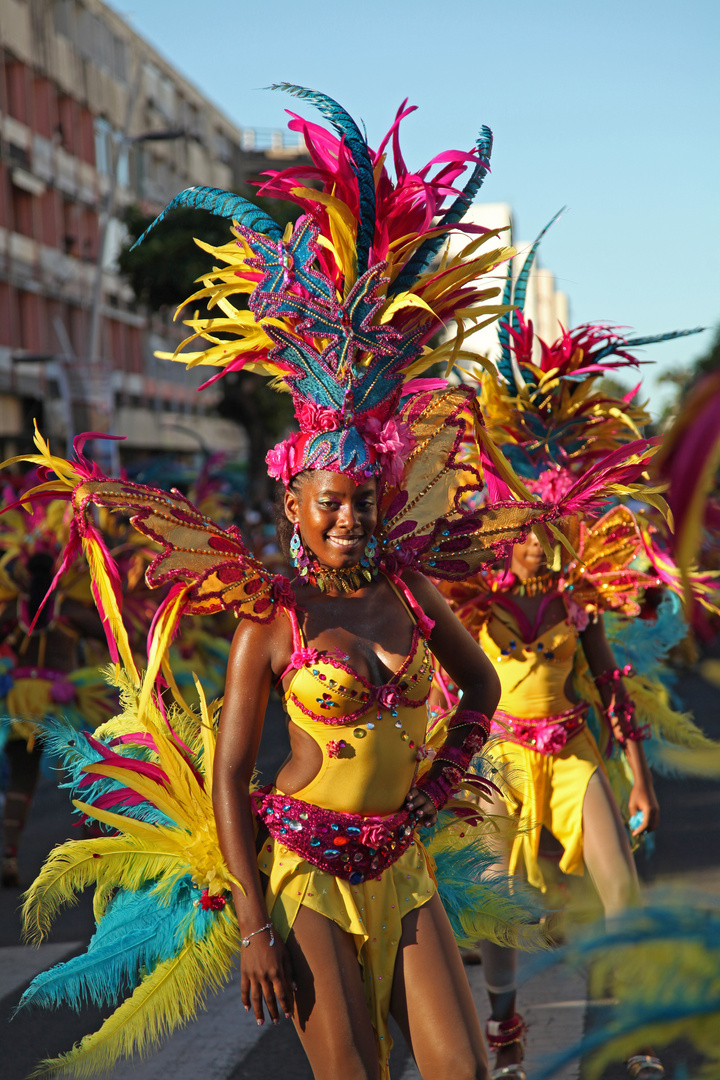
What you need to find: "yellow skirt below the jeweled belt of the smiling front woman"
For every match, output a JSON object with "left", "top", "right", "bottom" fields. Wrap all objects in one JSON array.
[{"left": 258, "top": 837, "right": 436, "bottom": 1078}]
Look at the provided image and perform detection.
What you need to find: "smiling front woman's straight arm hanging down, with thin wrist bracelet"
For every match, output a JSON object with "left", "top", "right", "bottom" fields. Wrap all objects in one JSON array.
[{"left": 213, "top": 617, "right": 293, "bottom": 1024}]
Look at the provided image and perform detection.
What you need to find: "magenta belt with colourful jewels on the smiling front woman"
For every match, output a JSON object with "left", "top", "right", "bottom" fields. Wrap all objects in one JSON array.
[{"left": 253, "top": 787, "right": 416, "bottom": 885}]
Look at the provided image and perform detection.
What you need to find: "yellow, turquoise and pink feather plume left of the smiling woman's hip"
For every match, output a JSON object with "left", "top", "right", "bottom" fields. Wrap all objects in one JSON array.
[{"left": 21, "top": 679, "right": 242, "bottom": 1077}]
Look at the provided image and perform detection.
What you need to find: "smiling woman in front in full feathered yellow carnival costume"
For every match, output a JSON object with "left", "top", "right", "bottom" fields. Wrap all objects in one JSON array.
[{"left": 0, "top": 86, "right": 664, "bottom": 1080}]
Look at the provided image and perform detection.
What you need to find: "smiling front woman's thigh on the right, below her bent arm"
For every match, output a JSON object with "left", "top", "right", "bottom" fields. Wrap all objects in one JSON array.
[{"left": 391, "top": 893, "right": 488, "bottom": 1080}]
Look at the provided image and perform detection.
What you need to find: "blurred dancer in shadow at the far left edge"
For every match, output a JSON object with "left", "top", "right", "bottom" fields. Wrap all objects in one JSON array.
[{"left": 0, "top": 483, "right": 117, "bottom": 887}]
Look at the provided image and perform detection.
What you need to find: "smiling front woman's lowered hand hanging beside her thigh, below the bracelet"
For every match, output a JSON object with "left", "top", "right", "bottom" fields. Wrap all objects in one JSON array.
[{"left": 240, "top": 931, "right": 295, "bottom": 1026}]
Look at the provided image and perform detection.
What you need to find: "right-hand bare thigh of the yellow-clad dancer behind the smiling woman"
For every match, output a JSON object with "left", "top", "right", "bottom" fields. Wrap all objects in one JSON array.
[{"left": 583, "top": 769, "right": 640, "bottom": 918}]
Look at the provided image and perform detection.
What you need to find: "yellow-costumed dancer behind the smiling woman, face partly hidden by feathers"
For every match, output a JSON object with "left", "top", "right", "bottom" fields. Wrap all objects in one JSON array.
[{"left": 443, "top": 234, "right": 712, "bottom": 1080}]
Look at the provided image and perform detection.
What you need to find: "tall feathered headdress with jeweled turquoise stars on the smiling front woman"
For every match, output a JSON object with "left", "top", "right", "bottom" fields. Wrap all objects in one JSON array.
[{"left": 133, "top": 84, "right": 513, "bottom": 484}]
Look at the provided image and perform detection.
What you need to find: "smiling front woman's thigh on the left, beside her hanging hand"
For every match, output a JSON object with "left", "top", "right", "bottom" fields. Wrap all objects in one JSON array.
[{"left": 286, "top": 907, "right": 380, "bottom": 1080}]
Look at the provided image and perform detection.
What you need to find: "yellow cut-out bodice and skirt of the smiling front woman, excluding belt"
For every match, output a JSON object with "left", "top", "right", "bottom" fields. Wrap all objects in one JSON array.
[{"left": 258, "top": 578, "right": 435, "bottom": 1076}]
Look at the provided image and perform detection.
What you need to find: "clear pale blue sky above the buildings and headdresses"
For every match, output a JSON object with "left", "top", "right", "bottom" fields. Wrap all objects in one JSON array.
[{"left": 112, "top": 0, "right": 720, "bottom": 407}]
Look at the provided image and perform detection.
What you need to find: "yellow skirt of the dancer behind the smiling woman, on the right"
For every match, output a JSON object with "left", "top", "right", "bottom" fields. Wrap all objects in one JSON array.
[{"left": 485, "top": 728, "right": 604, "bottom": 892}]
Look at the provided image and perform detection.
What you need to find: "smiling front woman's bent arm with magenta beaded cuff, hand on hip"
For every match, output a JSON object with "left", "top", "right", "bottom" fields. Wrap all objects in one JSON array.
[{"left": 405, "top": 573, "right": 500, "bottom": 823}]
